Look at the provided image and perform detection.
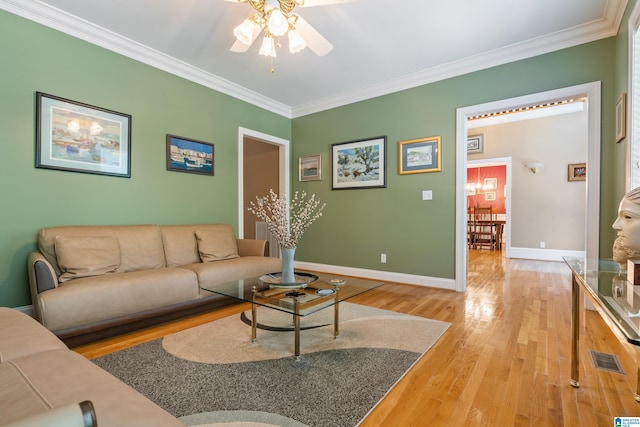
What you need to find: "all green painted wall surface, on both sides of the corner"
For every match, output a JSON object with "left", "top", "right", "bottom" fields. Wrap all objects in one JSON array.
[{"left": 0, "top": 1, "right": 635, "bottom": 307}]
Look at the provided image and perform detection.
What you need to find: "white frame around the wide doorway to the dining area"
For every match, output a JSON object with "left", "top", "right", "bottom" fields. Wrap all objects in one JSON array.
[{"left": 455, "top": 81, "right": 601, "bottom": 292}]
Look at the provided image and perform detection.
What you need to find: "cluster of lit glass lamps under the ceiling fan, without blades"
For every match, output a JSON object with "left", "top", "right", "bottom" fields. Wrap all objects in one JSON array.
[{"left": 233, "top": 0, "right": 307, "bottom": 58}]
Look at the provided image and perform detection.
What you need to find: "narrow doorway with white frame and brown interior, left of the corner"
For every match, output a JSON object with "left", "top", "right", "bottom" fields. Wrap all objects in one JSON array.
[{"left": 237, "top": 128, "right": 290, "bottom": 238}]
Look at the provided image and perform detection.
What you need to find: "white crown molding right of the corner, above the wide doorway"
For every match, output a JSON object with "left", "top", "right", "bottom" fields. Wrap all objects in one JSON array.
[{"left": 292, "top": 0, "right": 627, "bottom": 118}]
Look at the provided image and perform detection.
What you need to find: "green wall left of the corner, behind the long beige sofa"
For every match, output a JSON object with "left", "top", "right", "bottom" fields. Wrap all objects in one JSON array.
[{"left": 0, "top": 11, "right": 291, "bottom": 307}]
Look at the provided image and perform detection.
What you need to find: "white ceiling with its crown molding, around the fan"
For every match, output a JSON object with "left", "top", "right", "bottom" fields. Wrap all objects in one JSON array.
[{"left": 0, "top": 0, "right": 627, "bottom": 117}]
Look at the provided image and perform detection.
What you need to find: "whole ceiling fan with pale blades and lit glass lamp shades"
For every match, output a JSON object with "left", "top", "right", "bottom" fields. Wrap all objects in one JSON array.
[{"left": 227, "top": 0, "right": 354, "bottom": 57}]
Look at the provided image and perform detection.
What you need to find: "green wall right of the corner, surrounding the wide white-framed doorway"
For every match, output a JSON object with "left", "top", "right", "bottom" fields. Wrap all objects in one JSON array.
[{"left": 293, "top": 37, "right": 624, "bottom": 278}]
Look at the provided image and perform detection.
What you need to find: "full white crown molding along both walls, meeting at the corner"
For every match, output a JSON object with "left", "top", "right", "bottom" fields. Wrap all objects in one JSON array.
[{"left": 0, "top": 0, "right": 627, "bottom": 118}]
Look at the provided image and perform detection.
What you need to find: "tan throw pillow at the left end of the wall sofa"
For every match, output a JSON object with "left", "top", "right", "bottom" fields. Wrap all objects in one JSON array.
[{"left": 55, "top": 236, "right": 122, "bottom": 283}]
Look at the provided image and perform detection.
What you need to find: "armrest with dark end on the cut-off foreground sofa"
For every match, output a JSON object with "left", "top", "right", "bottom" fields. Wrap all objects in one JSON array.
[{"left": 4, "top": 400, "right": 98, "bottom": 427}]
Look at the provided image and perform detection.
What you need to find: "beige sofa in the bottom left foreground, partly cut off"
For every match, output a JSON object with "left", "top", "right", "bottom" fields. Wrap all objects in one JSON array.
[{"left": 0, "top": 307, "right": 184, "bottom": 427}]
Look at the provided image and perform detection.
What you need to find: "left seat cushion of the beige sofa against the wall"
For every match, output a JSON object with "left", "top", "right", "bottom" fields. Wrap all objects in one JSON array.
[{"left": 39, "top": 268, "right": 199, "bottom": 332}]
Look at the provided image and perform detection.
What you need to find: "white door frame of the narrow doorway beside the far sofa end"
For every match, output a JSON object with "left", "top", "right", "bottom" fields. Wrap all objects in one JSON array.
[{"left": 238, "top": 127, "right": 291, "bottom": 239}]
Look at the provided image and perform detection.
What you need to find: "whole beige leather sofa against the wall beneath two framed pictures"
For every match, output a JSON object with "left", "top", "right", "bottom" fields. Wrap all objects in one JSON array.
[{"left": 28, "top": 224, "right": 281, "bottom": 346}]
